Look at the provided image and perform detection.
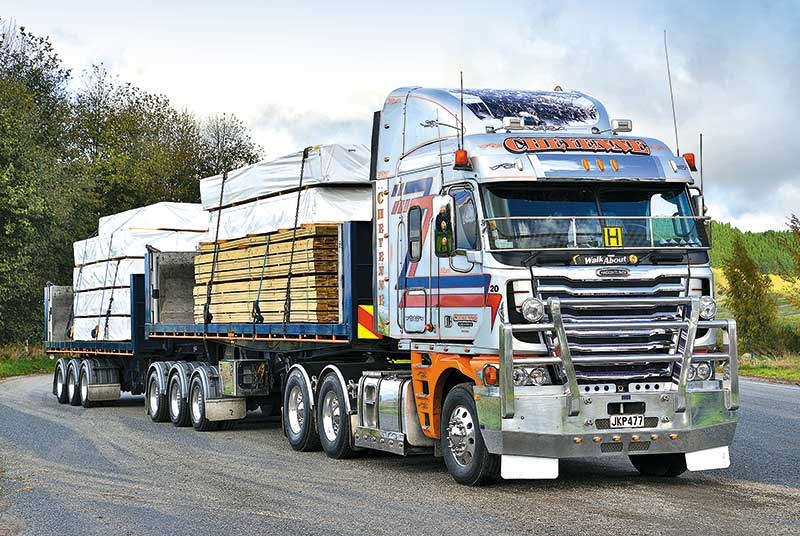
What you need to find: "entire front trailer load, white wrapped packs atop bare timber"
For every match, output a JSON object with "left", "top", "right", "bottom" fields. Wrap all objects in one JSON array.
[{"left": 194, "top": 145, "right": 372, "bottom": 323}]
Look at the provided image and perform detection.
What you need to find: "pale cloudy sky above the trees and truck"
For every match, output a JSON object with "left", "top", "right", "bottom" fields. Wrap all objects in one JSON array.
[{"left": 6, "top": 0, "right": 800, "bottom": 231}]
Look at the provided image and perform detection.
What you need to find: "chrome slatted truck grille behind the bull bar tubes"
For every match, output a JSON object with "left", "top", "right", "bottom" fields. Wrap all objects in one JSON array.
[{"left": 536, "top": 275, "right": 686, "bottom": 381}]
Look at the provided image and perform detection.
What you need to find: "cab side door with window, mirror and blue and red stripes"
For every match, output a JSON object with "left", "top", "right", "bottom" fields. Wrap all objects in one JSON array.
[{"left": 431, "top": 185, "right": 489, "bottom": 340}]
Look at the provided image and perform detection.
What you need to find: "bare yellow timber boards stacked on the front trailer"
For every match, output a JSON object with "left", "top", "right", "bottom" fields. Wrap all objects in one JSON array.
[{"left": 194, "top": 225, "right": 339, "bottom": 323}]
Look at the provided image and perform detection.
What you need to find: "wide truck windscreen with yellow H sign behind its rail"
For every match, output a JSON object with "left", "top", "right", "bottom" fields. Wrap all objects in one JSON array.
[{"left": 483, "top": 183, "right": 708, "bottom": 250}]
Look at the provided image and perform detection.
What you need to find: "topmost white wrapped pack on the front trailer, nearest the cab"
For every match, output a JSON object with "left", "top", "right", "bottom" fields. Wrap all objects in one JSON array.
[{"left": 200, "top": 144, "right": 370, "bottom": 210}]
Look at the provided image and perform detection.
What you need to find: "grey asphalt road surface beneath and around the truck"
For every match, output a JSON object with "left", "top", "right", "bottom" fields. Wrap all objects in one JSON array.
[{"left": 0, "top": 376, "right": 800, "bottom": 536}]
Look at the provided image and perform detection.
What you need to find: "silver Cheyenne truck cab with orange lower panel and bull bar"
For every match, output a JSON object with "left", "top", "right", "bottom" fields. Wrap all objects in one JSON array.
[{"left": 372, "top": 88, "right": 738, "bottom": 483}]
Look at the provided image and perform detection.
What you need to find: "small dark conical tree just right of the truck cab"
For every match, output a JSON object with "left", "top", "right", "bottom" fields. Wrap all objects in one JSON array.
[{"left": 722, "top": 236, "right": 778, "bottom": 353}]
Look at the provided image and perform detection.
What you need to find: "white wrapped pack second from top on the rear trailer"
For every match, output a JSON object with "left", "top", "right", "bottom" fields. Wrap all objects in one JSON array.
[{"left": 72, "top": 229, "right": 208, "bottom": 266}]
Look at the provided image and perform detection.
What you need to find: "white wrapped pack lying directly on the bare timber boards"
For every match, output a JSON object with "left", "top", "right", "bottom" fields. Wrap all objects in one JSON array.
[{"left": 209, "top": 186, "right": 372, "bottom": 240}]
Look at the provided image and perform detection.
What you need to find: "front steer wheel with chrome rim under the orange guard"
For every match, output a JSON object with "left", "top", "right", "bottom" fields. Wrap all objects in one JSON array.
[{"left": 440, "top": 383, "right": 500, "bottom": 486}]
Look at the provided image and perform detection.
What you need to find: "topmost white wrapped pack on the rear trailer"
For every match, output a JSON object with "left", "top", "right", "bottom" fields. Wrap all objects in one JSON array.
[{"left": 97, "top": 202, "right": 208, "bottom": 236}]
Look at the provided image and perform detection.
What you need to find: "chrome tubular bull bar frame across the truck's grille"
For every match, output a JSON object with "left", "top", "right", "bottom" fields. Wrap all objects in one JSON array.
[{"left": 499, "top": 296, "right": 739, "bottom": 419}]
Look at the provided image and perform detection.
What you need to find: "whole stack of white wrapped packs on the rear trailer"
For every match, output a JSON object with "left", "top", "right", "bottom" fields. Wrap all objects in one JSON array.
[{"left": 69, "top": 203, "right": 208, "bottom": 341}]
